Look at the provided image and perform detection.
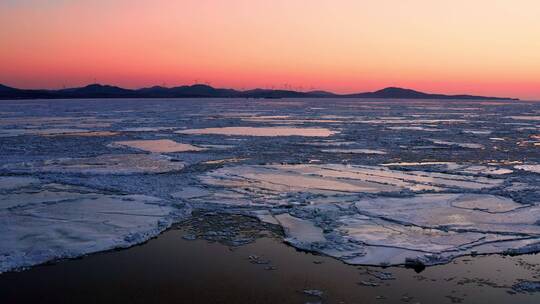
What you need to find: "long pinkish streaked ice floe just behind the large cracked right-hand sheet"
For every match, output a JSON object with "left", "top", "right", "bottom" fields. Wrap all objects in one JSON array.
[{"left": 201, "top": 164, "right": 504, "bottom": 200}]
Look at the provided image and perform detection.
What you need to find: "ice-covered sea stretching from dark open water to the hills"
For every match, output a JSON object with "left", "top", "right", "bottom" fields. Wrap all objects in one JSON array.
[{"left": 0, "top": 99, "right": 540, "bottom": 300}]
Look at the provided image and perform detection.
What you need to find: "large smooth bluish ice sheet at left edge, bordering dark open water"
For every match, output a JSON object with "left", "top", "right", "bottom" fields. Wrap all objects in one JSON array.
[{"left": 0, "top": 185, "right": 189, "bottom": 273}]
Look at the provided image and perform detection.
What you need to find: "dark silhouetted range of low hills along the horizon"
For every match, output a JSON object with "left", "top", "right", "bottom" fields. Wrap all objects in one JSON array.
[{"left": 0, "top": 84, "right": 517, "bottom": 100}]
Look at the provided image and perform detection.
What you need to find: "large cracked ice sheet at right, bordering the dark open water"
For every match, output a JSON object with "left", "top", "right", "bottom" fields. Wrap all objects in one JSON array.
[{"left": 253, "top": 194, "right": 540, "bottom": 265}]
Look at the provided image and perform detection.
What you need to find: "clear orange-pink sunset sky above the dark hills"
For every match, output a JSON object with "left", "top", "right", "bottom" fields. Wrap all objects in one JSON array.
[{"left": 0, "top": 0, "right": 540, "bottom": 100}]
